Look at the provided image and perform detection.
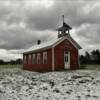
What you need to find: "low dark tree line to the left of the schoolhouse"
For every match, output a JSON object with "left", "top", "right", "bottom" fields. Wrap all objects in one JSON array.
[{"left": 0, "top": 59, "right": 22, "bottom": 65}]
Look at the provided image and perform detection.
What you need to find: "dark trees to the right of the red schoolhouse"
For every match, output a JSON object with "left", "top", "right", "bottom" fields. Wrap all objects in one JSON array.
[{"left": 80, "top": 49, "right": 100, "bottom": 64}]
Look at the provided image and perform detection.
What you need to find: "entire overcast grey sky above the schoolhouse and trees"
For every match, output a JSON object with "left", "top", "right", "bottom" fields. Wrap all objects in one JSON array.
[{"left": 0, "top": 0, "right": 100, "bottom": 60}]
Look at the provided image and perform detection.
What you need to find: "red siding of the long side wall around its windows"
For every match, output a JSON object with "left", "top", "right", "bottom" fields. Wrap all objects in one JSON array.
[{"left": 23, "top": 49, "right": 52, "bottom": 72}]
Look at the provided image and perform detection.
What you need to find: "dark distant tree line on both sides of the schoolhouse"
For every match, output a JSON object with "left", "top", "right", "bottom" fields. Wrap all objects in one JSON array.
[{"left": 0, "top": 49, "right": 100, "bottom": 65}]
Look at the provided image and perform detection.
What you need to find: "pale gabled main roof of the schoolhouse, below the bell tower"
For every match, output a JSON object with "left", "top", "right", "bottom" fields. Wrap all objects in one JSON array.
[{"left": 24, "top": 35, "right": 81, "bottom": 54}]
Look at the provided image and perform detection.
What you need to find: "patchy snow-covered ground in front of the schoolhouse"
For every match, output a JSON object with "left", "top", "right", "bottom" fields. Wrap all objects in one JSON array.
[{"left": 0, "top": 68, "right": 100, "bottom": 100}]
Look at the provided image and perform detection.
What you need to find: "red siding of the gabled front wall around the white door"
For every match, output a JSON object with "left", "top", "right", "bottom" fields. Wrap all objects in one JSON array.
[{"left": 54, "top": 40, "right": 78, "bottom": 70}]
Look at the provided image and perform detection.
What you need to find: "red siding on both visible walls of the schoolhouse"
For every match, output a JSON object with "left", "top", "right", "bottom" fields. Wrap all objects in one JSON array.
[{"left": 23, "top": 39, "right": 79, "bottom": 72}]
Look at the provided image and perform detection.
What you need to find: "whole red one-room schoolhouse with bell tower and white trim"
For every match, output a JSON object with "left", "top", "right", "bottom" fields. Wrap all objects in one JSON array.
[{"left": 23, "top": 16, "right": 81, "bottom": 72}]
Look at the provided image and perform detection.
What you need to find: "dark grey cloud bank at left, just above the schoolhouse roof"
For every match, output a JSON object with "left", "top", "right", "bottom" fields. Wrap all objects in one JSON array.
[{"left": 0, "top": 28, "right": 52, "bottom": 49}]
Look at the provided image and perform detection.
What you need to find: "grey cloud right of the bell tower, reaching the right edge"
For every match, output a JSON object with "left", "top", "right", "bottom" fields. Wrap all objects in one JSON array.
[{"left": 76, "top": 24, "right": 100, "bottom": 45}]
